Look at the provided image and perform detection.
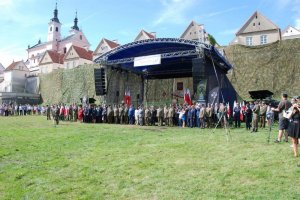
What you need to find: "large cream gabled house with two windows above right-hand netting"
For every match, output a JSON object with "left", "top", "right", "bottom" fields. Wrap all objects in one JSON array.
[{"left": 230, "top": 11, "right": 281, "bottom": 46}]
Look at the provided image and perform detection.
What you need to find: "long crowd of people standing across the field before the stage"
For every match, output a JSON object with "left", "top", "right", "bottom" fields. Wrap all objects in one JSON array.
[{"left": 0, "top": 94, "right": 300, "bottom": 156}]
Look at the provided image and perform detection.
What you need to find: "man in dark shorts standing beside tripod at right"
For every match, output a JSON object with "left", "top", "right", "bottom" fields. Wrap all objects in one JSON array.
[{"left": 272, "top": 94, "right": 292, "bottom": 143}]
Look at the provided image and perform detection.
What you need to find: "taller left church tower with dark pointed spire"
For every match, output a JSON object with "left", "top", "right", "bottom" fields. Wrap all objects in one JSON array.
[{"left": 47, "top": 3, "right": 61, "bottom": 42}]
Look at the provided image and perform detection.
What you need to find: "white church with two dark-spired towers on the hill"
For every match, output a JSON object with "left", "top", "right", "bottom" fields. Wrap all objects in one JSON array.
[{"left": 25, "top": 4, "right": 91, "bottom": 75}]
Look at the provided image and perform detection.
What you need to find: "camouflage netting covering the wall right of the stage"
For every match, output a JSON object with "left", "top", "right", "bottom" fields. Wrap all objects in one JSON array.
[{"left": 225, "top": 39, "right": 300, "bottom": 99}]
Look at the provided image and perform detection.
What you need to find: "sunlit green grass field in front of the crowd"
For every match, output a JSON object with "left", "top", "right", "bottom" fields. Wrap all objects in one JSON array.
[{"left": 0, "top": 116, "right": 300, "bottom": 199}]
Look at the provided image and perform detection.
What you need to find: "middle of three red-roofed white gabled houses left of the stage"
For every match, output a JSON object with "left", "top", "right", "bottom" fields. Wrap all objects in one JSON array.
[{"left": 64, "top": 45, "right": 93, "bottom": 69}]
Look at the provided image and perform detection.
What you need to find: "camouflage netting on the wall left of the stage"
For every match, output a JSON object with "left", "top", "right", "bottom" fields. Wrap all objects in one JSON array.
[{"left": 40, "top": 64, "right": 103, "bottom": 104}]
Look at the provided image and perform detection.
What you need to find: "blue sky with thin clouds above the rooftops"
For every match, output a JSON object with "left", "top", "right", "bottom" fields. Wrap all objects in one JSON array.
[{"left": 0, "top": 0, "right": 300, "bottom": 67}]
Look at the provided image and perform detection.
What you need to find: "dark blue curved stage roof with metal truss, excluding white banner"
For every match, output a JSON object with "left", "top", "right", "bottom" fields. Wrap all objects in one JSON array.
[{"left": 94, "top": 38, "right": 232, "bottom": 78}]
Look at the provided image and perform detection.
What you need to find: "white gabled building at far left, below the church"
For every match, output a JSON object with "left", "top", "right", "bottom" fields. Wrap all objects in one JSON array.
[{"left": 0, "top": 61, "right": 29, "bottom": 92}]
